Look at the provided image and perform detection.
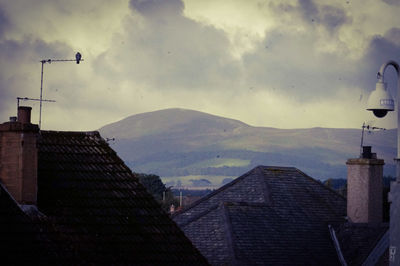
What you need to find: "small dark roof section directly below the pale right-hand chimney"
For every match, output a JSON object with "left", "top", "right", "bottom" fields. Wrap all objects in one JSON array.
[{"left": 333, "top": 223, "right": 389, "bottom": 265}]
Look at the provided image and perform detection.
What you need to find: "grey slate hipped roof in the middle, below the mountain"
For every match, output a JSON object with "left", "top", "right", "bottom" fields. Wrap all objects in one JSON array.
[{"left": 173, "top": 166, "right": 346, "bottom": 265}]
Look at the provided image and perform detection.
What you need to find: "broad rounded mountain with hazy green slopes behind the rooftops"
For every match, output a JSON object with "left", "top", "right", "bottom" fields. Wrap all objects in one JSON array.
[{"left": 99, "top": 109, "right": 396, "bottom": 186}]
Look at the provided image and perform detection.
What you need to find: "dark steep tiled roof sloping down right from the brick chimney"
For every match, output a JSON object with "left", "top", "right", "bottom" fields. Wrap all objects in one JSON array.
[{"left": 0, "top": 131, "right": 207, "bottom": 265}]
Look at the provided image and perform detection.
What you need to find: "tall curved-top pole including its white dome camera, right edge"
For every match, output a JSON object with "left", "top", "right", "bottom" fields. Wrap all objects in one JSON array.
[{"left": 367, "top": 61, "right": 400, "bottom": 265}]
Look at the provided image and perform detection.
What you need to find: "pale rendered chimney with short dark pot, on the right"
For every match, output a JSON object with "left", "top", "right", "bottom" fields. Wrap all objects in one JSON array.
[{"left": 346, "top": 146, "right": 385, "bottom": 223}]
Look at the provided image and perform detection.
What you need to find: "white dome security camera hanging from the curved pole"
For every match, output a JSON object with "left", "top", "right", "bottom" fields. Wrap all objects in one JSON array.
[{"left": 367, "top": 81, "right": 394, "bottom": 118}]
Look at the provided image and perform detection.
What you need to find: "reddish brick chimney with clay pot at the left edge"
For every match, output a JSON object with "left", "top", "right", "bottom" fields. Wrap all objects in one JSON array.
[{"left": 0, "top": 106, "right": 39, "bottom": 205}]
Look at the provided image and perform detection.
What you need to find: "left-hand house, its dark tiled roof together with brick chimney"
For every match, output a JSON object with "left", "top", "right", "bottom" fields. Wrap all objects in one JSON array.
[{"left": 0, "top": 107, "right": 207, "bottom": 265}]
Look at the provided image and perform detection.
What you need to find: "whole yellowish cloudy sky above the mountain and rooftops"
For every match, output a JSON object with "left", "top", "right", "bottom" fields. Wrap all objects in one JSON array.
[{"left": 0, "top": 0, "right": 400, "bottom": 130}]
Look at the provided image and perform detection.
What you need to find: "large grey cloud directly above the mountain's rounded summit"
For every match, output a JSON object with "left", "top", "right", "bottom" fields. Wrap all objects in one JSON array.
[{"left": 96, "top": 0, "right": 240, "bottom": 90}]
